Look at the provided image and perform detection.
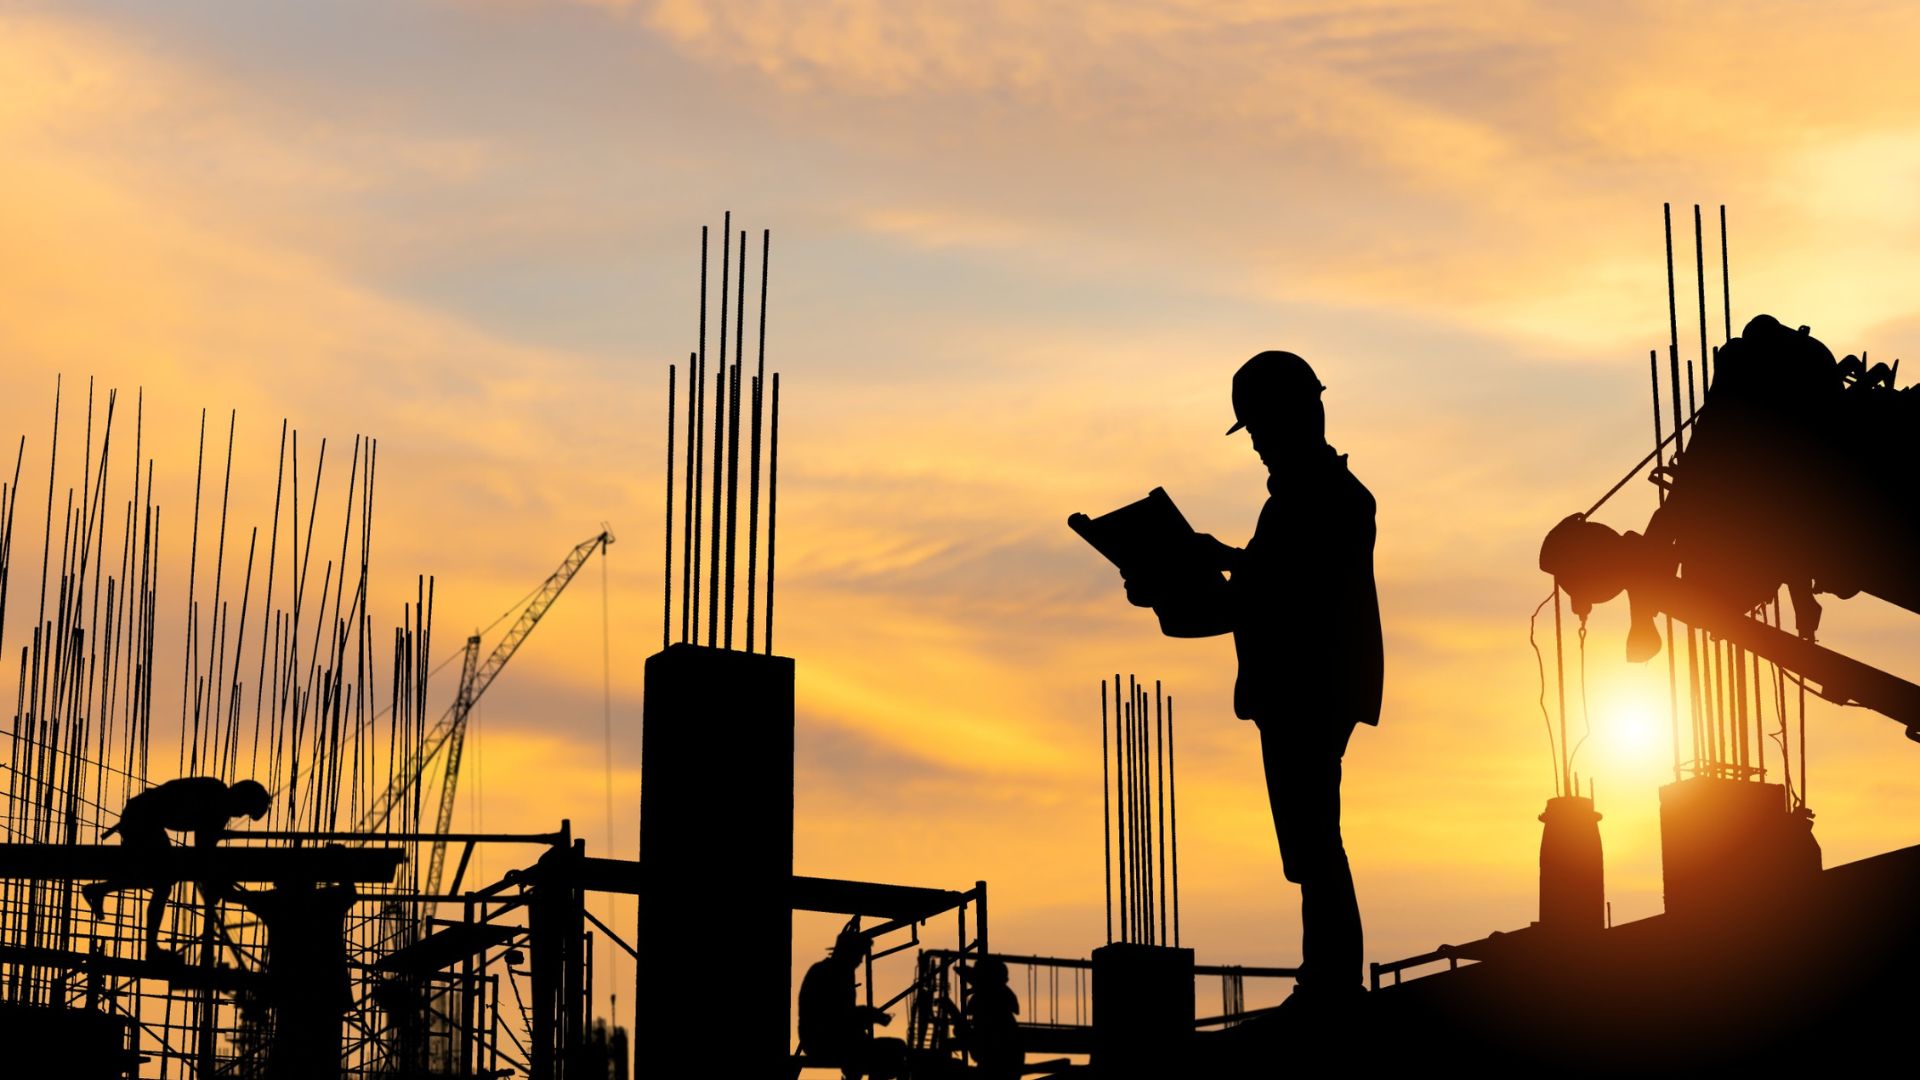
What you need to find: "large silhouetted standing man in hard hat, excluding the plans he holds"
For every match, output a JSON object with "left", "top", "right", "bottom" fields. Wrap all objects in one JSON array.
[{"left": 1127, "top": 352, "right": 1384, "bottom": 1009}]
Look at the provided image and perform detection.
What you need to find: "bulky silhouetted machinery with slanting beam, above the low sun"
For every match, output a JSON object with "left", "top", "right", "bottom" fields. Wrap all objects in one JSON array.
[{"left": 1540, "top": 307, "right": 1920, "bottom": 737}]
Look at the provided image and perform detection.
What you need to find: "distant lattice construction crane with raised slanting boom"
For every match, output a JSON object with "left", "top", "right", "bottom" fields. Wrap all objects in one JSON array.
[{"left": 361, "top": 528, "right": 612, "bottom": 894}]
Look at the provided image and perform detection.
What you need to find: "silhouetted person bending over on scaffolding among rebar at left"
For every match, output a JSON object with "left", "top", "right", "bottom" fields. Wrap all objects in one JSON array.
[{"left": 81, "top": 776, "right": 269, "bottom": 961}]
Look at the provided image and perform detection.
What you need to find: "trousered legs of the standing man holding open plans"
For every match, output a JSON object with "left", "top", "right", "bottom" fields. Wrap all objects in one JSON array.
[{"left": 1260, "top": 723, "right": 1363, "bottom": 992}]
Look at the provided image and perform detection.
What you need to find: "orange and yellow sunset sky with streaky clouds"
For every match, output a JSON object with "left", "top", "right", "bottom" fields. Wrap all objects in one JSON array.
[{"left": 0, "top": 0, "right": 1920, "bottom": 1037}]
